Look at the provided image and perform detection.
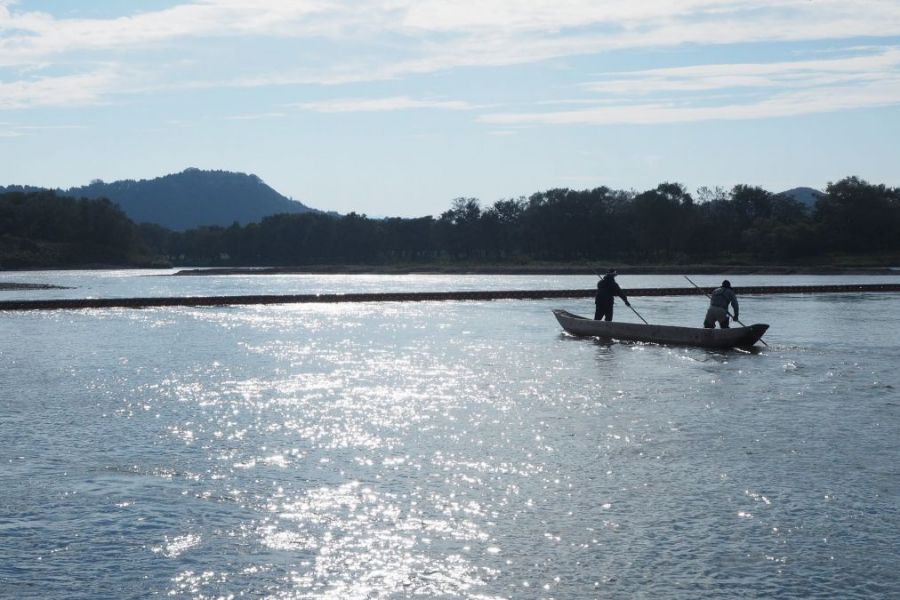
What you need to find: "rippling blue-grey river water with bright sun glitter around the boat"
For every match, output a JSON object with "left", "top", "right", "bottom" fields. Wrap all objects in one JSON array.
[{"left": 0, "top": 271, "right": 900, "bottom": 600}]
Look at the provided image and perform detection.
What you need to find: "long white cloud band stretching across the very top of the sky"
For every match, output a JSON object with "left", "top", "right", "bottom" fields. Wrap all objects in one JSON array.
[{"left": 0, "top": 0, "right": 900, "bottom": 78}]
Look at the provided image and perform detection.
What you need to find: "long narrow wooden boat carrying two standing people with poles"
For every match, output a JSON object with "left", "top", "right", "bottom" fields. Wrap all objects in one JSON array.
[{"left": 553, "top": 309, "right": 769, "bottom": 348}]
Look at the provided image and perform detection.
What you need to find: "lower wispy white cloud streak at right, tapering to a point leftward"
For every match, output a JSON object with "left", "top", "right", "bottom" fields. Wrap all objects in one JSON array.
[{"left": 479, "top": 48, "right": 900, "bottom": 125}]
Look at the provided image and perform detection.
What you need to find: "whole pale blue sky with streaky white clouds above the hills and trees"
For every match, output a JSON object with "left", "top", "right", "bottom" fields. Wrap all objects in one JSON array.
[{"left": 0, "top": 0, "right": 900, "bottom": 217}]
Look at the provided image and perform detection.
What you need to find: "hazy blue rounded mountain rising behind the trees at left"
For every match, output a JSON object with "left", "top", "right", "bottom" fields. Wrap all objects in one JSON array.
[{"left": 60, "top": 168, "right": 317, "bottom": 231}]
